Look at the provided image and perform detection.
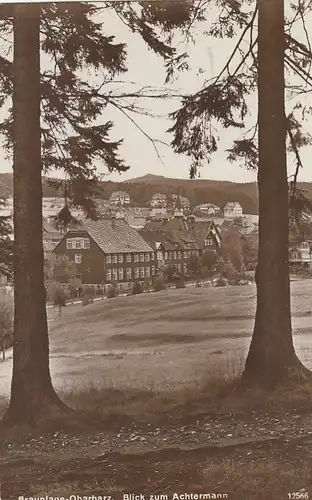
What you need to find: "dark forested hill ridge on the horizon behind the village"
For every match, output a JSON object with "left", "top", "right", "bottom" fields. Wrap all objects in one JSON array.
[{"left": 0, "top": 173, "right": 312, "bottom": 214}]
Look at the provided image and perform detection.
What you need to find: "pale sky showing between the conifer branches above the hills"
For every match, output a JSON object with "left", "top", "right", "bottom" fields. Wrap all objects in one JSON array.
[{"left": 0, "top": 0, "right": 312, "bottom": 186}]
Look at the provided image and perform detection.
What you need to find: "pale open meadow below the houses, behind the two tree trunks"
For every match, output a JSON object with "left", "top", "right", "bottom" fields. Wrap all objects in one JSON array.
[{"left": 0, "top": 280, "right": 312, "bottom": 395}]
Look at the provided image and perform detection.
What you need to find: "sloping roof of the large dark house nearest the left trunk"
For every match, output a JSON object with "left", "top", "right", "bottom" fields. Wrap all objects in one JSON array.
[{"left": 75, "top": 219, "right": 153, "bottom": 253}]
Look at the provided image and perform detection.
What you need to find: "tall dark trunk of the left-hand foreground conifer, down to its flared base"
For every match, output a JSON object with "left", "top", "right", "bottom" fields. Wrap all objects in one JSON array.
[{"left": 3, "top": 4, "right": 70, "bottom": 425}]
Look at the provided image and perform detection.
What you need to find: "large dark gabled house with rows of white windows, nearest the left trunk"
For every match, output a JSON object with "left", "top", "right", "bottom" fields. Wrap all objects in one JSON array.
[{"left": 54, "top": 217, "right": 156, "bottom": 288}]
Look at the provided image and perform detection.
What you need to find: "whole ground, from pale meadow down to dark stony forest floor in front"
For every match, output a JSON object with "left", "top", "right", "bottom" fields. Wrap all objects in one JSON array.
[{"left": 0, "top": 280, "right": 312, "bottom": 500}]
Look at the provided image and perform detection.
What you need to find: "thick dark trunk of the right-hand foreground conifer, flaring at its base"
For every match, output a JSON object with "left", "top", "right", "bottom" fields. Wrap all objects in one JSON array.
[{"left": 243, "top": 0, "right": 309, "bottom": 387}]
